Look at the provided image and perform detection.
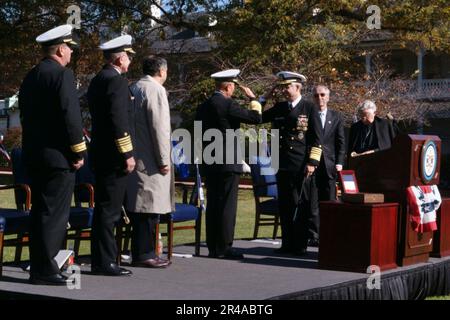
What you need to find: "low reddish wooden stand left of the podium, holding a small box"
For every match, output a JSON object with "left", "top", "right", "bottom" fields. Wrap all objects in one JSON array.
[{"left": 319, "top": 201, "right": 398, "bottom": 273}]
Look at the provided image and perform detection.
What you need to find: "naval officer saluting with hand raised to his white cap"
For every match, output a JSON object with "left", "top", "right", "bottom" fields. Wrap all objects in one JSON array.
[{"left": 196, "top": 69, "right": 261, "bottom": 259}]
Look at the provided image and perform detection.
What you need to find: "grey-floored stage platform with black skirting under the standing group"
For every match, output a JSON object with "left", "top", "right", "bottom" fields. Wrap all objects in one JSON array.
[{"left": 0, "top": 240, "right": 450, "bottom": 300}]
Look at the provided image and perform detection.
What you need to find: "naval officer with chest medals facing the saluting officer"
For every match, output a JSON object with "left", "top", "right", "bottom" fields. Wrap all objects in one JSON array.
[{"left": 261, "top": 71, "right": 322, "bottom": 255}]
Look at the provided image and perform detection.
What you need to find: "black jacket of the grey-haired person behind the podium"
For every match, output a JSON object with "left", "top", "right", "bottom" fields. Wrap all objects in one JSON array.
[{"left": 347, "top": 116, "right": 395, "bottom": 157}]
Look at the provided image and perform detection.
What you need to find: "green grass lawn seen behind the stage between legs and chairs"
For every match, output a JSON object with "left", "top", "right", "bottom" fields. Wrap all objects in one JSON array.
[{"left": 0, "top": 190, "right": 281, "bottom": 262}]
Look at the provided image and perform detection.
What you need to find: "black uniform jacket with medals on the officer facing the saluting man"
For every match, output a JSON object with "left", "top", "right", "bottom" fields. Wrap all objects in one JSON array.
[{"left": 262, "top": 98, "right": 321, "bottom": 172}]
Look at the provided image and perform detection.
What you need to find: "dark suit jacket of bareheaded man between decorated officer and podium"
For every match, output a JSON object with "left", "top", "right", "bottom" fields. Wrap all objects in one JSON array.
[{"left": 321, "top": 109, "right": 345, "bottom": 179}]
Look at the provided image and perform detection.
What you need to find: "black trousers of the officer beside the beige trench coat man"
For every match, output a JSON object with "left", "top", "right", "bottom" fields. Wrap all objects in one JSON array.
[{"left": 91, "top": 171, "right": 128, "bottom": 268}]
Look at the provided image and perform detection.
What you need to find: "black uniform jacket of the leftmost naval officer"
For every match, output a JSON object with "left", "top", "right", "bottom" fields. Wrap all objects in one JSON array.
[{"left": 19, "top": 58, "right": 86, "bottom": 169}]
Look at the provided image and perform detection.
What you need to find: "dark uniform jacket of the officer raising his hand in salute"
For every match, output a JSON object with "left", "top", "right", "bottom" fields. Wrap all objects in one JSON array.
[{"left": 195, "top": 92, "right": 261, "bottom": 173}]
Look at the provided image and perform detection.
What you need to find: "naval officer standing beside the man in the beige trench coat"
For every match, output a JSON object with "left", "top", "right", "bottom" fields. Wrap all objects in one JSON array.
[{"left": 87, "top": 35, "right": 135, "bottom": 276}]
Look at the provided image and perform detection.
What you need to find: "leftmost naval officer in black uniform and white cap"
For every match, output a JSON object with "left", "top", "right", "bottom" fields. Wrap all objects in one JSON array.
[{"left": 19, "top": 25, "right": 86, "bottom": 285}]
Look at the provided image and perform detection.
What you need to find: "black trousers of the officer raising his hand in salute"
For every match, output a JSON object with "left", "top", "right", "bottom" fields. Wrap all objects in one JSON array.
[{"left": 205, "top": 172, "right": 240, "bottom": 255}]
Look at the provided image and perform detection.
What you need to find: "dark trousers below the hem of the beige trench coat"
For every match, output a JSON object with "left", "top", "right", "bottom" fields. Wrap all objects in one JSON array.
[{"left": 128, "top": 212, "right": 159, "bottom": 262}]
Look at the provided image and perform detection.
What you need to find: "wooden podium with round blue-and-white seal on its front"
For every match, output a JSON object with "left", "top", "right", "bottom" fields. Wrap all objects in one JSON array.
[{"left": 349, "top": 135, "right": 441, "bottom": 266}]
